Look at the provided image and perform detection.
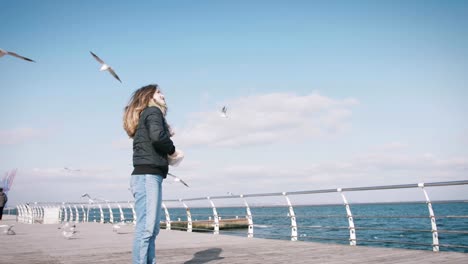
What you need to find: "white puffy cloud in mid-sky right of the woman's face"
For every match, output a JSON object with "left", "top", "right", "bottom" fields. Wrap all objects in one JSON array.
[{"left": 175, "top": 93, "right": 358, "bottom": 147}]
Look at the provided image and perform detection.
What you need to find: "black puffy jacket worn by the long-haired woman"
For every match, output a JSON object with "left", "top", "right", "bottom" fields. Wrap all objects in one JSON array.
[{"left": 132, "top": 106, "right": 175, "bottom": 178}]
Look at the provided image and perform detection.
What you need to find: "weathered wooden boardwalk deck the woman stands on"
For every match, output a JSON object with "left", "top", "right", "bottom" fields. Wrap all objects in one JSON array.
[{"left": 0, "top": 216, "right": 468, "bottom": 264}]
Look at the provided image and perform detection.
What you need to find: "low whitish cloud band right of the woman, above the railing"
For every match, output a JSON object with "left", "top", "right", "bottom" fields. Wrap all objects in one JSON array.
[{"left": 161, "top": 147, "right": 468, "bottom": 202}]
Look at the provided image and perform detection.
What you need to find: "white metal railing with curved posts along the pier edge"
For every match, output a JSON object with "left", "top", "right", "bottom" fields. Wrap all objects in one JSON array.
[{"left": 17, "top": 180, "right": 468, "bottom": 252}]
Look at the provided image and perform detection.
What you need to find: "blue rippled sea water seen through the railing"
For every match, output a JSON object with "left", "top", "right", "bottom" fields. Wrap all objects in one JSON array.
[{"left": 75, "top": 201, "right": 468, "bottom": 253}]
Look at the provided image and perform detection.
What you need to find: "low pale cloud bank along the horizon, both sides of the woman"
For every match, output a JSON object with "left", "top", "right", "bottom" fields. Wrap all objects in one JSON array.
[{"left": 7, "top": 144, "right": 468, "bottom": 203}]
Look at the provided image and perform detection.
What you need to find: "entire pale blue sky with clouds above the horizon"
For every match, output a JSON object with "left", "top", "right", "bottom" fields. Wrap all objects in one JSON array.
[{"left": 0, "top": 0, "right": 468, "bottom": 205}]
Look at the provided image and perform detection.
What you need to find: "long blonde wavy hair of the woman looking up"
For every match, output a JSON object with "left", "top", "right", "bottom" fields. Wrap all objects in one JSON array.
[{"left": 123, "top": 84, "right": 167, "bottom": 138}]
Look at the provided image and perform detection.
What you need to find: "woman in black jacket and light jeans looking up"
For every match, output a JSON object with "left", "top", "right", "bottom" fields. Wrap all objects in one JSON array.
[{"left": 123, "top": 85, "right": 177, "bottom": 264}]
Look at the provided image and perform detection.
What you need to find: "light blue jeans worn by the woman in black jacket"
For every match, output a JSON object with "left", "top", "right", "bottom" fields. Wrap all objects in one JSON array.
[{"left": 130, "top": 174, "right": 163, "bottom": 264}]
